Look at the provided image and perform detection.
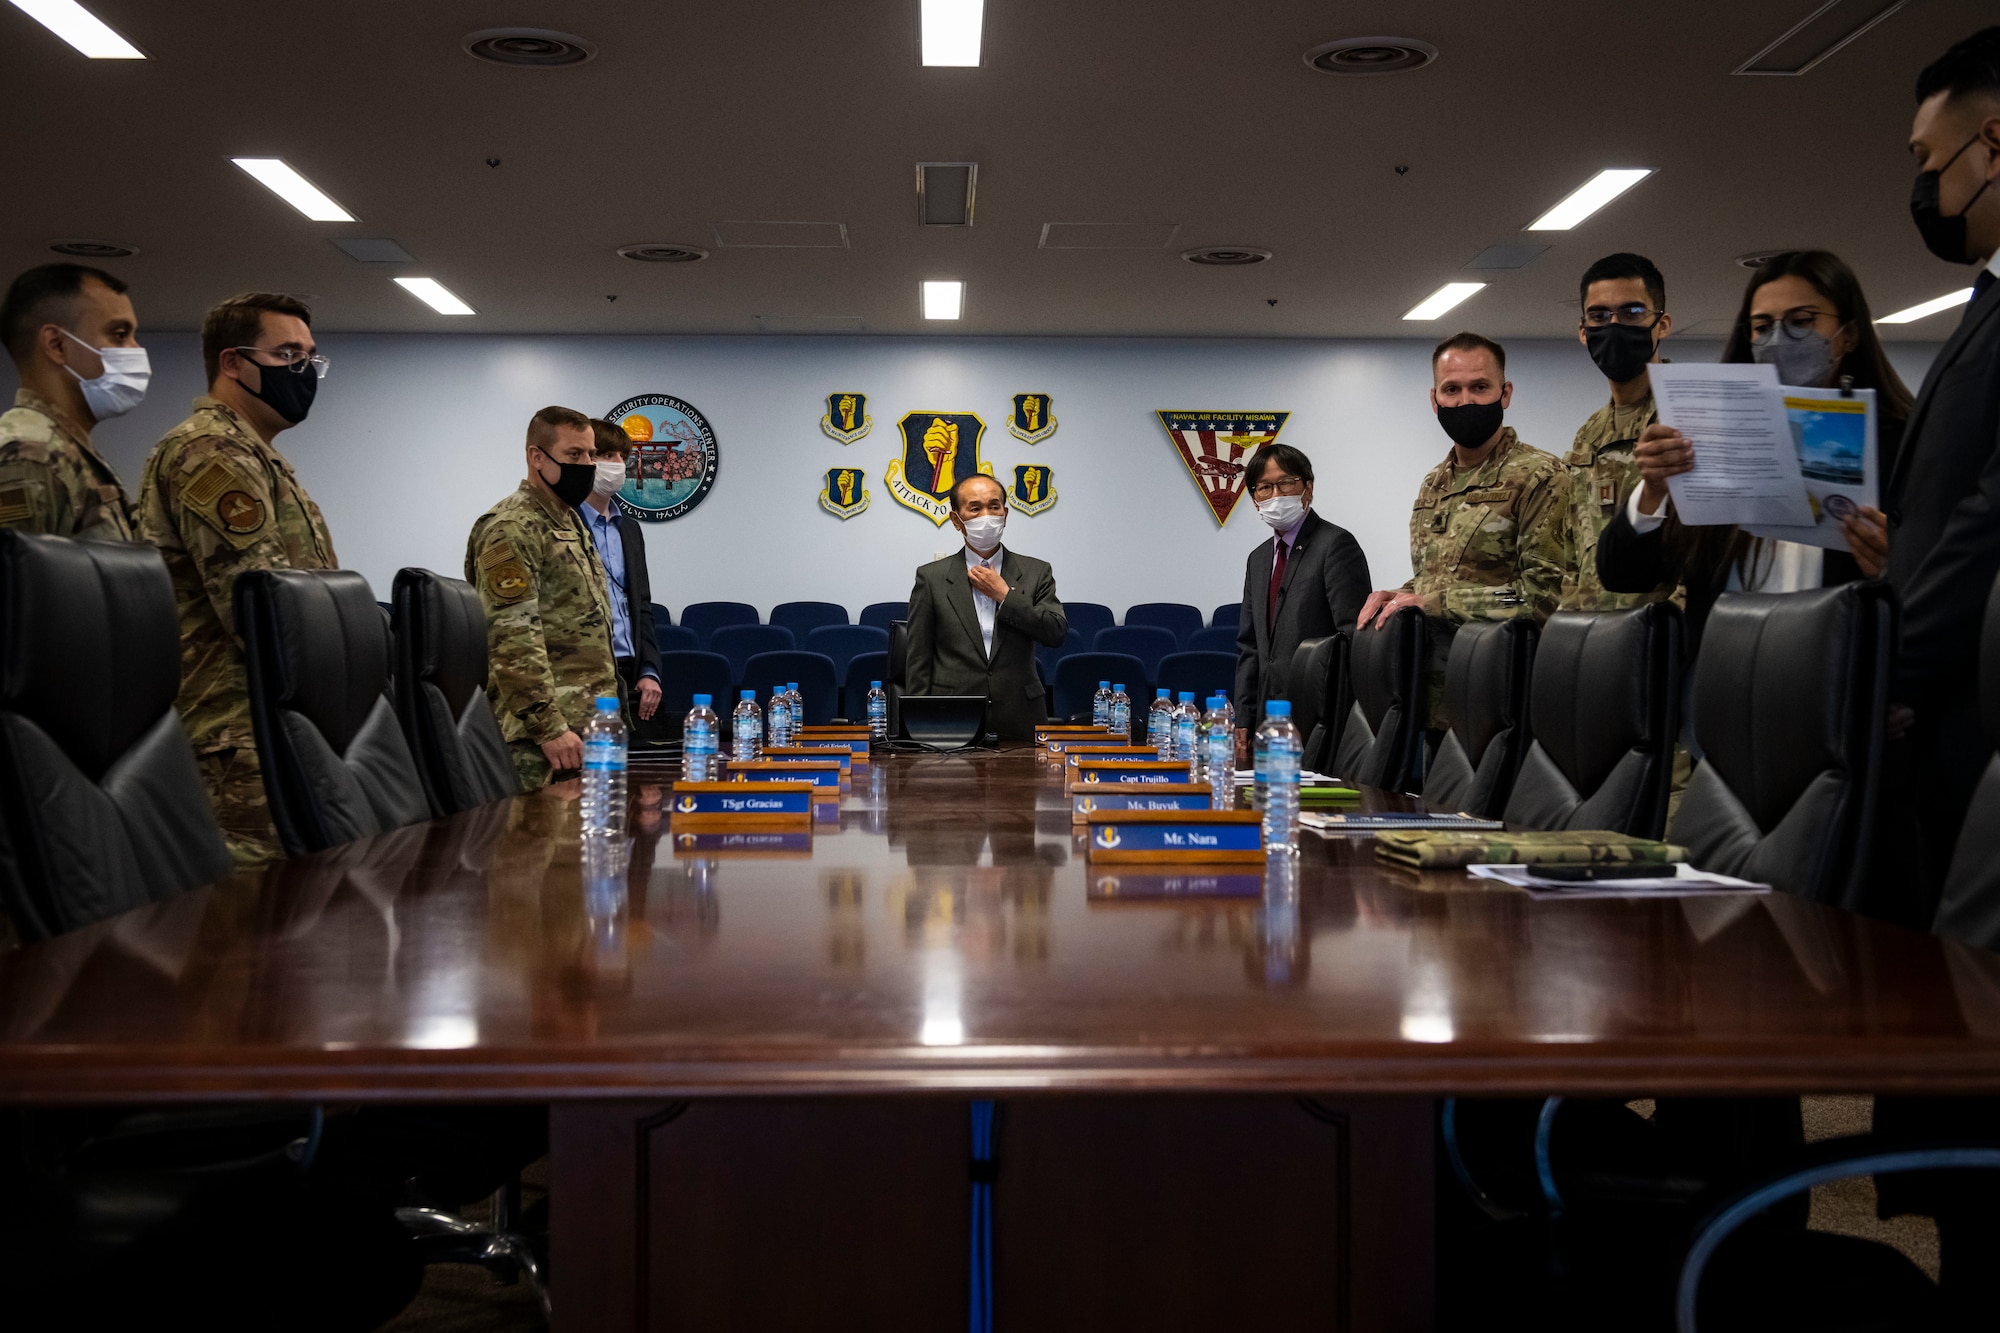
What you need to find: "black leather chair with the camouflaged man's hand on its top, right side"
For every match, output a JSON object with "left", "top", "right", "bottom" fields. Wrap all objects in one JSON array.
[{"left": 1334, "top": 606, "right": 1430, "bottom": 791}]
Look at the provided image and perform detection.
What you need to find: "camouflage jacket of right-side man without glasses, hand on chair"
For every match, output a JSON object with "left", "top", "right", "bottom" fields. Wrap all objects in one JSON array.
[{"left": 1402, "top": 426, "right": 1570, "bottom": 624}]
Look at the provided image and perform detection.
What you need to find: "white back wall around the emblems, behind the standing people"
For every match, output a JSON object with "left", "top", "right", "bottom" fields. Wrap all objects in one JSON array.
[{"left": 0, "top": 330, "right": 1936, "bottom": 618}]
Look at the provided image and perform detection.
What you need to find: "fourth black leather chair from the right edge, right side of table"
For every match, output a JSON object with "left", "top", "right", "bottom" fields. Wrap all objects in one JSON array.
[{"left": 1424, "top": 620, "right": 1538, "bottom": 819}]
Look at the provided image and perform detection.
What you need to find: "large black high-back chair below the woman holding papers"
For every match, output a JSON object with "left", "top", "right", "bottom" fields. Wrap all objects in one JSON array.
[{"left": 1668, "top": 582, "right": 1894, "bottom": 907}]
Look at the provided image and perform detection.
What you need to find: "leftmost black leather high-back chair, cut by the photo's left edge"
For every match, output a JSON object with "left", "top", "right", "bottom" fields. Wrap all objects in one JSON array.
[{"left": 0, "top": 530, "right": 232, "bottom": 943}]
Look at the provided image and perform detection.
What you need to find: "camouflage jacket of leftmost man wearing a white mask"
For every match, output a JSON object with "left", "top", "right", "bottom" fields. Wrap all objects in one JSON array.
[{"left": 0, "top": 388, "right": 138, "bottom": 542}]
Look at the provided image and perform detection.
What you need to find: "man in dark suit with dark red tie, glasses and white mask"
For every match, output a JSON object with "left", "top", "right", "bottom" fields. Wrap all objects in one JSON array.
[{"left": 1236, "top": 444, "right": 1372, "bottom": 751}]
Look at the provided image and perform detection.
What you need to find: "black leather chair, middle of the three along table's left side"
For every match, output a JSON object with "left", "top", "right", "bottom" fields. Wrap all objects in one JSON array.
[{"left": 236, "top": 570, "right": 430, "bottom": 857}]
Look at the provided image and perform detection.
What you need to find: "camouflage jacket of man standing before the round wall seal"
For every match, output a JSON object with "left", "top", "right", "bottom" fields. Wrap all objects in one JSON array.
[{"left": 466, "top": 482, "right": 618, "bottom": 745}]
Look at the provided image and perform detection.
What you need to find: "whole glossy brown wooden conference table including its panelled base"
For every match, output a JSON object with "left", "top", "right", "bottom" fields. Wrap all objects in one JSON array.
[{"left": 0, "top": 749, "right": 2000, "bottom": 1331}]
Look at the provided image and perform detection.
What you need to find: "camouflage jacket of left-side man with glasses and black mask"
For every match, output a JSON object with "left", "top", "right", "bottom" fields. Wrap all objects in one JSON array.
[{"left": 138, "top": 396, "right": 340, "bottom": 755}]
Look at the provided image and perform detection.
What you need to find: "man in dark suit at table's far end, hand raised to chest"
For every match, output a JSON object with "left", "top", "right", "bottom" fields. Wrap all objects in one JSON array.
[{"left": 904, "top": 472, "right": 1070, "bottom": 741}]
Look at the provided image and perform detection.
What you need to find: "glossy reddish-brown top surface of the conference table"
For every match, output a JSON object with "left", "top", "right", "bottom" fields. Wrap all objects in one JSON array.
[{"left": 0, "top": 751, "right": 2000, "bottom": 1101}]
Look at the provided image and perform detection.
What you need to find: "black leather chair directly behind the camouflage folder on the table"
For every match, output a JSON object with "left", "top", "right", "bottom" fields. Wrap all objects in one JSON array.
[{"left": 1502, "top": 602, "right": 1682, "bottom": 839}]
